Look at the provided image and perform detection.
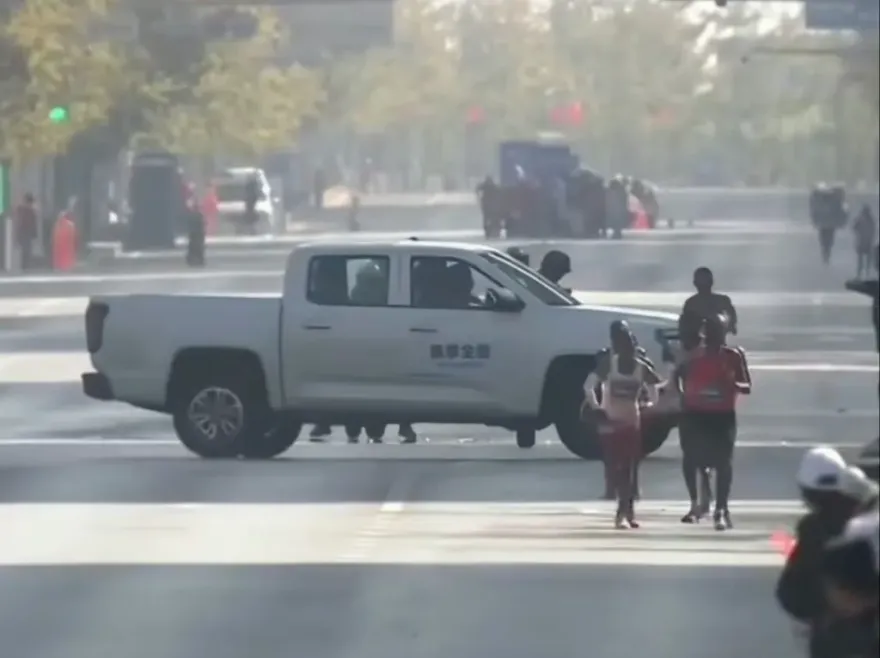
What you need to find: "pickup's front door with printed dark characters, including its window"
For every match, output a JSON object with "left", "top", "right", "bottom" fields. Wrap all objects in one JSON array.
[{"left": 404, "top": 256, "right": 527, "bottom": 415}]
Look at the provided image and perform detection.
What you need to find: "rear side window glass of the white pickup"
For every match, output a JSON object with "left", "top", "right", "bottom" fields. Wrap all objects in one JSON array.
[{"left": 306, "top": 256, "right": 391, "bottom": 306}]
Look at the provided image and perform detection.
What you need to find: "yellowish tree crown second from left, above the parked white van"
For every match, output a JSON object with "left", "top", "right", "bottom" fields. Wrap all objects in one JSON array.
[{"left": 149, "top": 10, "right": 323, "bottom": 155}]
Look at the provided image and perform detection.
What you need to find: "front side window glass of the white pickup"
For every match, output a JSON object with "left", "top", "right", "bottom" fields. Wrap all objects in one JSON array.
[{"left": 410, "top": 256, "right": 503, "bottom": 309}]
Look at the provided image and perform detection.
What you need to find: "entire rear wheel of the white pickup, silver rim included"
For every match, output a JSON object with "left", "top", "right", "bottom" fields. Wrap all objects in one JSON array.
[{"left": 173, "top": 374, "right": 270, "bottom": 459}]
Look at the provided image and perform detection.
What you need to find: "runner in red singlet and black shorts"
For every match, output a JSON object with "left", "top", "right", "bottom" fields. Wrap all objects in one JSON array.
[{"left": 673, "top": 315, "right": 752, "bottom": 530}]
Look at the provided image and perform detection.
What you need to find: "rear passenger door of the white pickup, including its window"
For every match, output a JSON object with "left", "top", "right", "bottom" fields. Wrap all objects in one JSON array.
[{"left": 282, "top": 253, "right": 403, "bottom": 410}]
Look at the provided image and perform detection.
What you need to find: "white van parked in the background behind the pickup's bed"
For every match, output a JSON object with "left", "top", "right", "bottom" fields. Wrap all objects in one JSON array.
[{"left": 212, "top": 167, "right": 279, "bottom": 235}]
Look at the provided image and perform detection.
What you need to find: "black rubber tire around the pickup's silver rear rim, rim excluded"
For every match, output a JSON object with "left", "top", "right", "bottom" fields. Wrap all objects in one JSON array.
[{"left": 173, "top": 373, "right": 271, "bottom": 459}]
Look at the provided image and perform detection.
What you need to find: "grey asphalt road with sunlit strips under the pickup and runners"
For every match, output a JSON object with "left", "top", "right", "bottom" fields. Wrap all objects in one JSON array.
[{"left": 0, "top": 211, "right": 878, "bottom": 658}]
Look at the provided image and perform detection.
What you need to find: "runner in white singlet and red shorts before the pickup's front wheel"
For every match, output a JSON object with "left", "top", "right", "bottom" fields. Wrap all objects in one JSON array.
[{"left": 584, "top": 331, "right": 660, "bottom": 528}]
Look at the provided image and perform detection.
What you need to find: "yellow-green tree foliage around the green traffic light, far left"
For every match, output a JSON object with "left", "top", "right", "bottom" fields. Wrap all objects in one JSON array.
[{"left": 0, "top": 0, "right": 134, "bottom": 160}]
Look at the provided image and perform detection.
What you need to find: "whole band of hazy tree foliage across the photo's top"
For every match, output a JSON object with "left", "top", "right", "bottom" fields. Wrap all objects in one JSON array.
[{"left": 0, "top": 0, "right": 878, "bottom": 183}]
